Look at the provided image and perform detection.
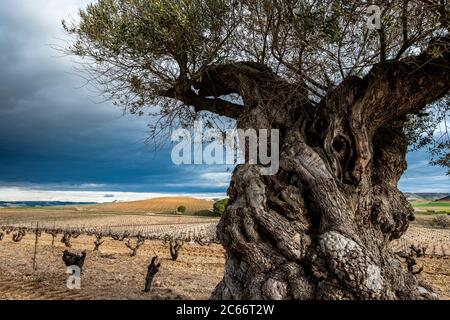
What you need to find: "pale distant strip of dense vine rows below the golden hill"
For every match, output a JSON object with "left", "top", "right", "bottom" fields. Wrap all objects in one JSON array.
[{"left": 0, "top": 215, "right": 450, "bottom": 257}]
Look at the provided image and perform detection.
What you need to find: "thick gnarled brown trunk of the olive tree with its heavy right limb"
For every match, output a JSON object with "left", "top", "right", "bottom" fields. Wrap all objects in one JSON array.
[{"left": 211, "top": 40, "right": 450, "bottom": 299}]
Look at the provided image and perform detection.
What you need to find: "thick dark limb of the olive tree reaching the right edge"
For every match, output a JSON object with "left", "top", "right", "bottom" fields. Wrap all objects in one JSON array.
[{"left": 320, "top": 37, "right": 450, "bottom": 133}]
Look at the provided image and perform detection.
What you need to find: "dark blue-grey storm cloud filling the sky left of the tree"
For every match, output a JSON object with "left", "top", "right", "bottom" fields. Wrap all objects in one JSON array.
[{"left": 0, "top": 0, "right": 229, "bottom": 190}]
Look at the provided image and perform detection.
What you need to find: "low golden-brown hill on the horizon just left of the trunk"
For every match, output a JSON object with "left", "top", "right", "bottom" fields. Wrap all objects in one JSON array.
[{"left": 93, "top": 197, "right": 214, "bottom": 213}]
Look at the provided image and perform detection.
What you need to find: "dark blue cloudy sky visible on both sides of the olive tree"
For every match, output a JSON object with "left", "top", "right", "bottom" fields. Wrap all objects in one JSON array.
[{"left": 0, "top": 0, "right": 450, "bottom": 201}]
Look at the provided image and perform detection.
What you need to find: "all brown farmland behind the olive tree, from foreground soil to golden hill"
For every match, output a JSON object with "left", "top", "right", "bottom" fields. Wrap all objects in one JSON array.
[{"left": 0, "top": 198, "right": 450, "bottom": 299}]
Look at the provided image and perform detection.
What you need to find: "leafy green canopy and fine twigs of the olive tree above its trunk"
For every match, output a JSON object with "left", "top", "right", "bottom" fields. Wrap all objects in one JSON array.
[{"left": 63, "top": 0, "right": 450, "bottom": 172}]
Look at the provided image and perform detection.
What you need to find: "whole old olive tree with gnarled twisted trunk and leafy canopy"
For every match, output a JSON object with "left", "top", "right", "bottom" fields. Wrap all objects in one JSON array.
[{"left": 63, "top": 0, "right": 450, "bottom": 299}]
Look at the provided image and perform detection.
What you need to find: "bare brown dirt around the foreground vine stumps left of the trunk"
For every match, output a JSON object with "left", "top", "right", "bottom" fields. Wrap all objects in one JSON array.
[{"left": 0, "top": 235, "right": 224, "bottom": 300}]
